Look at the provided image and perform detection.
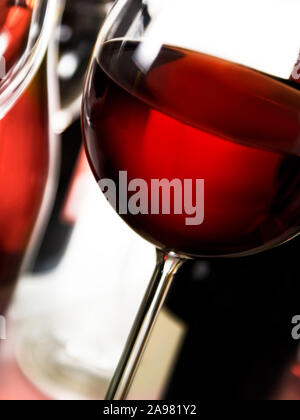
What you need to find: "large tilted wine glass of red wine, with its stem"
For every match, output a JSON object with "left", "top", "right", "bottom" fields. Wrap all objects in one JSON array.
[{"left": 82, "top": 0, "right": 300, "bottom": 399}]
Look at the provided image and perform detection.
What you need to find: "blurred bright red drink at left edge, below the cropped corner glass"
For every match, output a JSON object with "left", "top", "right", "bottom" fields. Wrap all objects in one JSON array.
[{"left": 0, "top": 60, "right": 49, "bottom": 314}]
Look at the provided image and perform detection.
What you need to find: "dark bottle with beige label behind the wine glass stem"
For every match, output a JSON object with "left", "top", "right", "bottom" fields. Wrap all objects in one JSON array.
[{"left": 129, "top": 237, "right": 300, "bottom": 401}]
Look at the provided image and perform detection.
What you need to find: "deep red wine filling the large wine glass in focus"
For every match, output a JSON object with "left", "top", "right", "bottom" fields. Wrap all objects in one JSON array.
[{"left": 83, "top": 41, "right": 300, "bottom": 255}]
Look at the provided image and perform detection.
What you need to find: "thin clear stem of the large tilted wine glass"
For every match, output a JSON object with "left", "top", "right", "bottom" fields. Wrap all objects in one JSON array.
[{"left": 105, "top": 250, "right": 186, "bottom": 401}]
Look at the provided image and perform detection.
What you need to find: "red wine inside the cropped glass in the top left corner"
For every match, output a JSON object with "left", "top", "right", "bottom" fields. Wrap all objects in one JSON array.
[{"left": 0, "top": 0, "right": 35, "bottom": 71}]
